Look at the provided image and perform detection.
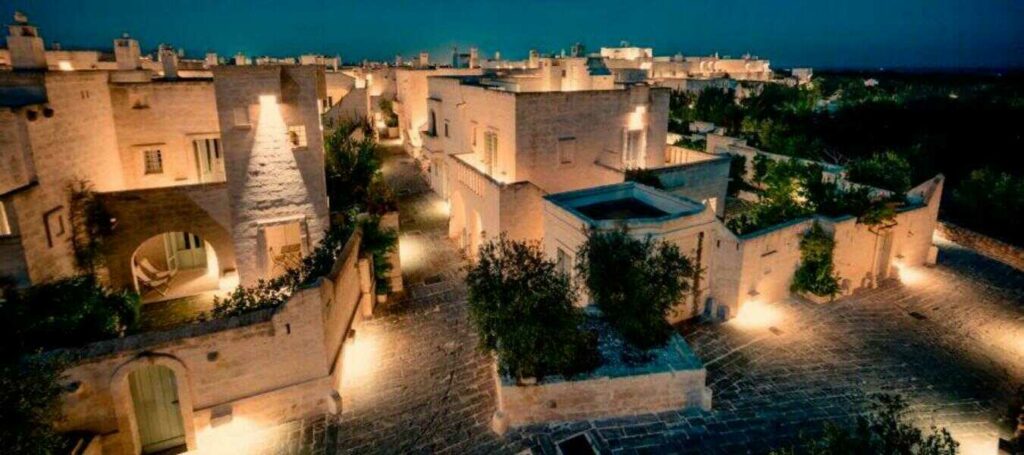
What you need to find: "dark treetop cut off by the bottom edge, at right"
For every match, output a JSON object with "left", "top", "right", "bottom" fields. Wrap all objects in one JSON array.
[{"left": 772, "top": 395, "right": 959, "bottom": 455}]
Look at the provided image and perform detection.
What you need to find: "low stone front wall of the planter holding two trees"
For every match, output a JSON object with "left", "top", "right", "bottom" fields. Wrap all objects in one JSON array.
[{"left": 498, "top": 368, "right": 712, "bottom": 426}]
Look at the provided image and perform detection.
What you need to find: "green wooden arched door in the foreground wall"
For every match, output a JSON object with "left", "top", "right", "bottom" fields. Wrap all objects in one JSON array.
[{"left": 128, "top": 365, "right": 185, "bottom": 453}]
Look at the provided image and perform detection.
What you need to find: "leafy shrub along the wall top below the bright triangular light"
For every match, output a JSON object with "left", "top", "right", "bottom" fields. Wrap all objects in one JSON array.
[{"left": 210, "top": 224, "right": 352, "bottom": 318}]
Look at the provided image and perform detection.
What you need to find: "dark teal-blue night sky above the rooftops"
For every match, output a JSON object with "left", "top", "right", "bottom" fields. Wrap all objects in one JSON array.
[{"left": 0, "top": 0, "right": 1024, "bottom": 68}]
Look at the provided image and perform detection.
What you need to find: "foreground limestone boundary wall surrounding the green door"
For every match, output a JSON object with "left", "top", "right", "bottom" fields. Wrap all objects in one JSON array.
[{"left": 58, "top": 233, "right": 374, "bottom": 454}]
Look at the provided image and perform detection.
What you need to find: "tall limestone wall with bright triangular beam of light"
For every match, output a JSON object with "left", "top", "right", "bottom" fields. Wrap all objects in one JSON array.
[{"left": 214, "top": 66, "right": 329, "bottom": 285}]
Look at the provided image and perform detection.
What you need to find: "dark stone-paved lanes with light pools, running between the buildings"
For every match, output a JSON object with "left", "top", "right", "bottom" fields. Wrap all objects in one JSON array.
[{"left": 273, "top": 147, "right": 1024, "bottom": 454}]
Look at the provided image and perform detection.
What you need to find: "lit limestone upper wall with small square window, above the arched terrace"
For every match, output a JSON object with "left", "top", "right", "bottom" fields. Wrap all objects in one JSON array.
[{"left": 111, "top": 80, "right": 223, "bottom": 189}]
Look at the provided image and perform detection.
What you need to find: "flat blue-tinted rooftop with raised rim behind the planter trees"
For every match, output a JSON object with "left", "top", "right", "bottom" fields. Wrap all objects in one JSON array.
[{"left": 545, "top": 181, "right": 705, "bottom": 226}]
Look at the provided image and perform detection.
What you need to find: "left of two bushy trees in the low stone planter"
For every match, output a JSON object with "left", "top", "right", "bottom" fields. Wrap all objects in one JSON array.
[{"left": 466, "top": 234, "right": 600, "bottom": 381}]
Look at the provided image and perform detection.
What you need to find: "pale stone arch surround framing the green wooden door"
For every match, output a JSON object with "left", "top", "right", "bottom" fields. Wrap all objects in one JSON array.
[{"left": 110, "top": 353, "right": 197, "bottom": 453}]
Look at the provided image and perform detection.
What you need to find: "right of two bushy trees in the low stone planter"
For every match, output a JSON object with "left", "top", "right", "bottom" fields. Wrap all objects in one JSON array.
[{"left": 577, "top": 230, "right": 694, "bottom": 350}]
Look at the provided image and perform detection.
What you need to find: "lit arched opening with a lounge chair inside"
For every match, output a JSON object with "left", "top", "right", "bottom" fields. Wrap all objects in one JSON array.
[{"left": 129, "top": 232, "right": 222, "bottom": 302}]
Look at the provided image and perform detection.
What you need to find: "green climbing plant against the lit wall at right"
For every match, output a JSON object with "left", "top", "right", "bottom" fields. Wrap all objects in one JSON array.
[{"left": 790, "top": 222, "right": 840, "bottom": 299}]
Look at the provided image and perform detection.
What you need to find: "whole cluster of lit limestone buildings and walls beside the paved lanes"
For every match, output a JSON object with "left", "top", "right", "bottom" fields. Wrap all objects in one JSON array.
[{"left": 0, "top": 9, "right": 942, "bottom": 453}]
